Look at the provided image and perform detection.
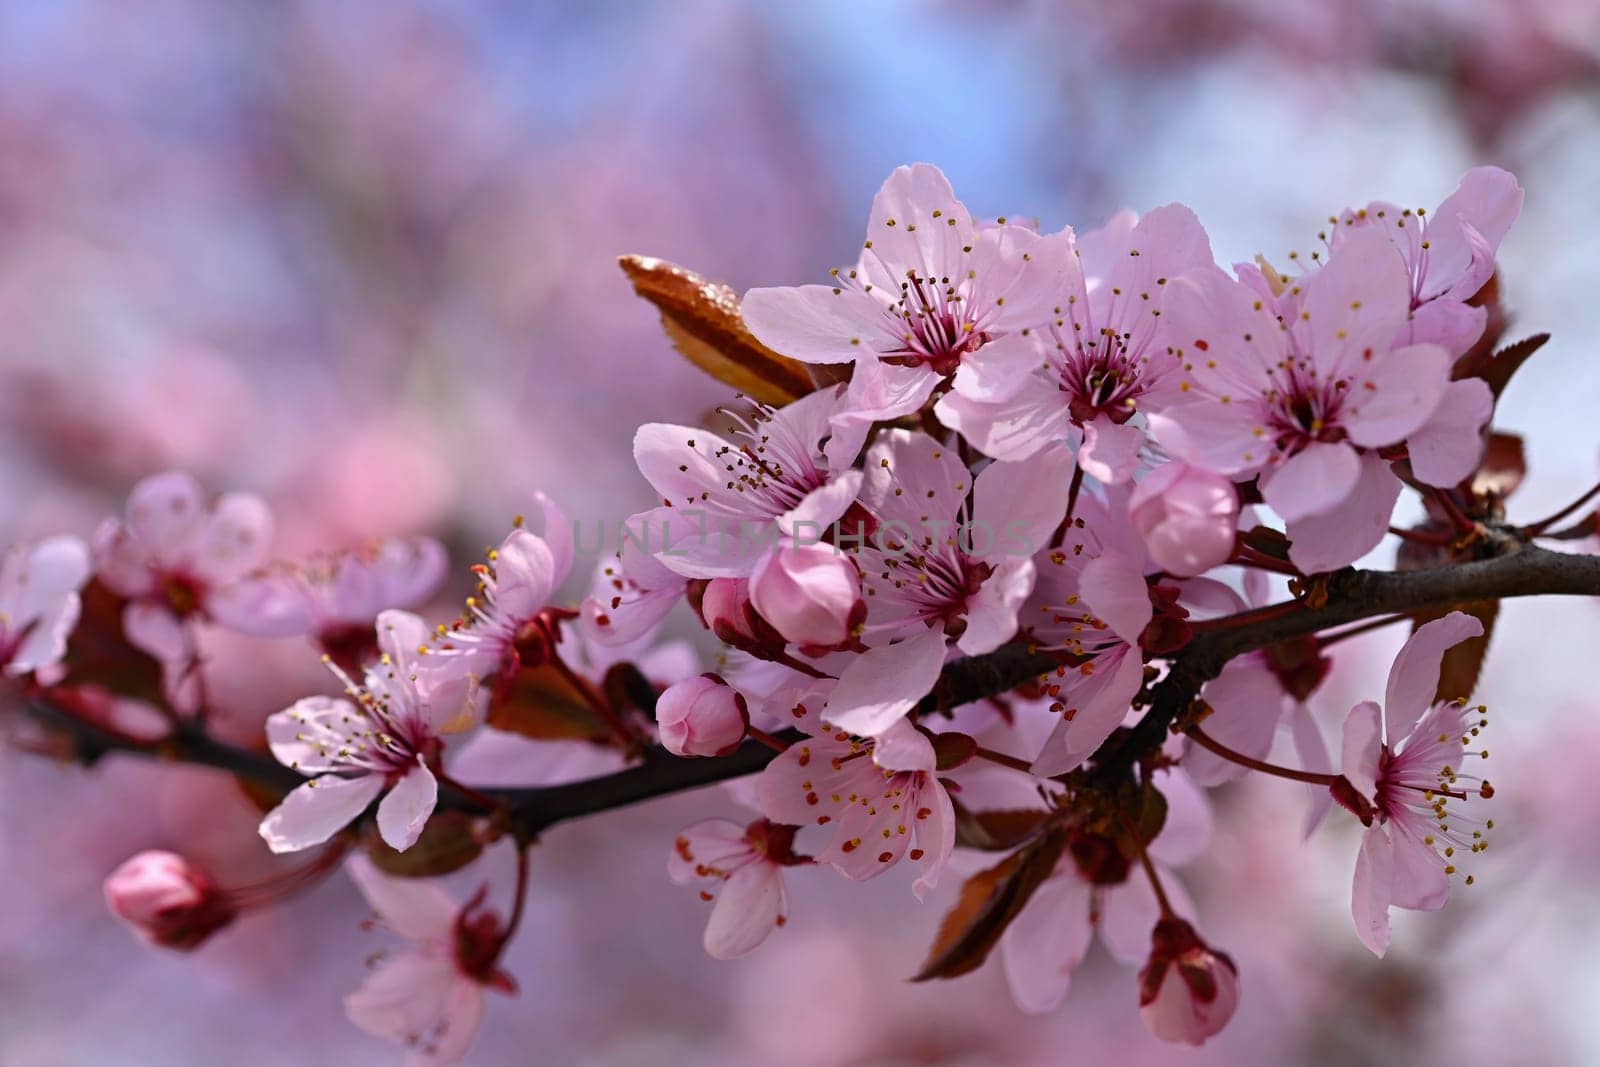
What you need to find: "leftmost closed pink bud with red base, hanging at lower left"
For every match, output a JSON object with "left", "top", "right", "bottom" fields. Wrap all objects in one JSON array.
[{"left": 106, "top": 851, "right": 235, "bottom": 949}]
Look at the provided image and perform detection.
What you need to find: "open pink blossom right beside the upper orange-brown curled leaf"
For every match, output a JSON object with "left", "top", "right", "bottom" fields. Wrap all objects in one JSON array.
[{"left": 741, "top": 163, "right": 1072, "bottom": 419}]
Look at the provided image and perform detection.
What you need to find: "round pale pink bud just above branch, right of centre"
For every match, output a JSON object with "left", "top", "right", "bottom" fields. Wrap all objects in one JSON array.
[{"left": 1128, "top": 462, "right": 1238, "bottom": 577}]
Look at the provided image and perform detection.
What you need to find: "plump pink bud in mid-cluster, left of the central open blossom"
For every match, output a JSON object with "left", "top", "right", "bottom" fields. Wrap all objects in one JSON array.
[{"left": 750, "top": 544, "right": 867, "bottom": 654}]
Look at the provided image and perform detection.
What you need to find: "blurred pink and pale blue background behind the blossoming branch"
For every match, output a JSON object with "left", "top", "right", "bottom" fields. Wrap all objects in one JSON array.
[{"left": 0, "top": 0, "right": 1600, "bottom": 1067}]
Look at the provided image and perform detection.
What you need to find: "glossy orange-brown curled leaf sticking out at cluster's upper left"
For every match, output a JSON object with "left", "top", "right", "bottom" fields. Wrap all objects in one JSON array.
[{"left": 619, "top": 256, "right": 816, "bottom": 405}]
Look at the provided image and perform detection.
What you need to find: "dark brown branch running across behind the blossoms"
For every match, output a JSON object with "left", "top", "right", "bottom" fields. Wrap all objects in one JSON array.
[{"left": 29, "top": 542, "right": 1600, "bottom": 840}]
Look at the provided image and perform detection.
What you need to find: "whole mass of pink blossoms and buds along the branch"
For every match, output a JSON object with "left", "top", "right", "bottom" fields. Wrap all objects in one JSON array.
[{"left": 0, "top": 165, "right": 1555, "bottom": 1062}]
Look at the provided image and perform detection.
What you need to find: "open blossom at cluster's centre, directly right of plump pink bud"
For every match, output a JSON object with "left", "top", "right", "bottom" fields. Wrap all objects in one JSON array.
[{"left": 826, "top": 430, "right": 1072, "bottom": 736}]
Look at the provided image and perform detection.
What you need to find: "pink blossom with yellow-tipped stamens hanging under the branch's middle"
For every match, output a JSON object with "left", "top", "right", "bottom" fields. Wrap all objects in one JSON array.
[{"left": 757, "top": 716, "right": 955, "bottom": 899}]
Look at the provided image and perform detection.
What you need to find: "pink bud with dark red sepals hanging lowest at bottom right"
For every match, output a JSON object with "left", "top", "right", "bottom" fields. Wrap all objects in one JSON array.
[{"left": 1139, "top": 918, "right": 1238, "bottom": 1045}]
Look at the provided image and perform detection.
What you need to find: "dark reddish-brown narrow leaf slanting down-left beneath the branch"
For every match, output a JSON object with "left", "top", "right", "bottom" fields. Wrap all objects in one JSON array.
[{"left": 912, "top": 825, "right": 1067, "bottom": 982}]
